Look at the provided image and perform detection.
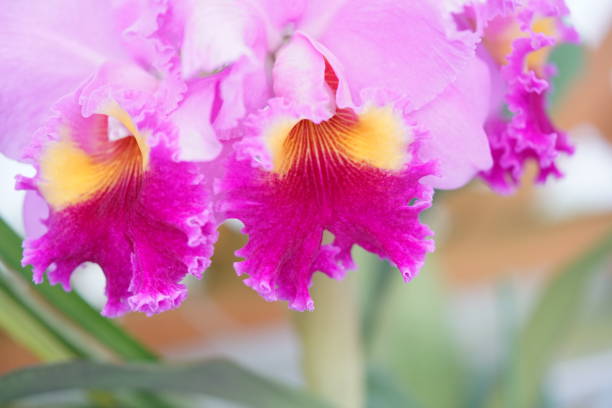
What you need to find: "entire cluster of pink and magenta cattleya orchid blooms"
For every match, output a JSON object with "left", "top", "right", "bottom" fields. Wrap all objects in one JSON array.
[{"left": 0, "top": 0, "right": 570, "bottom": 316}]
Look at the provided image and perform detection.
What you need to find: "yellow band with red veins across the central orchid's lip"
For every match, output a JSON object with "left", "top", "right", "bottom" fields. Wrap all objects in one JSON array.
[{"left": 265, "top": 107, "right": 411, "bottom": 175}]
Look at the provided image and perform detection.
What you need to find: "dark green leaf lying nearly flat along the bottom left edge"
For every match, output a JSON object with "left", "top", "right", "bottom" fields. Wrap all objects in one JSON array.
[{"left": 0, "top": 360, "right": 327, "bottom": 408}]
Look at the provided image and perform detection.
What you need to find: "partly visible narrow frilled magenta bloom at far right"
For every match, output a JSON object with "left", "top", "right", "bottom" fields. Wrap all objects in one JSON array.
[{"left": 459, "top": 0, "right": 577, "bottom": 193}]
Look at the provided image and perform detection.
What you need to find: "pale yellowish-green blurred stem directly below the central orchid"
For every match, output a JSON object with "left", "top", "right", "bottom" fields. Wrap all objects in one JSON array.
[{"left": 293, "top": 274, "right": 365, "bottom": 408}]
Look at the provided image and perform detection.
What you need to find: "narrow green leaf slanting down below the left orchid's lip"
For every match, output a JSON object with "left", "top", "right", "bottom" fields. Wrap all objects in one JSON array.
[{"left": 0, "top": 218, "right": 157, "bottom": 361}]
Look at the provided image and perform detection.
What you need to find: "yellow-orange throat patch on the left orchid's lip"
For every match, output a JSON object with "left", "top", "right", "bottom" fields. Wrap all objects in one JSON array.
[{"left": 38, "top": 105, "right": 149, "bottom": 211}]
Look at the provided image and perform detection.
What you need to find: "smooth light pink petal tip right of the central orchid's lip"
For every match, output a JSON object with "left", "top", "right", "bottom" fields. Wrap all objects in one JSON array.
[{"left": 413, "top": 58, "right": 492, "bottom": 189}]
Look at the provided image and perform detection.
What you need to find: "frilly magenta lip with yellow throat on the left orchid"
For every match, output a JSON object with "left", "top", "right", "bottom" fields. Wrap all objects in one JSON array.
[{"left": 19, "top": 65, "right": 216, "bottom": 316}]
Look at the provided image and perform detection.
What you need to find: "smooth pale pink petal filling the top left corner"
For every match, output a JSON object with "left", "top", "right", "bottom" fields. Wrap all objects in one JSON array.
[{"left": 0, "top": 0, "right": 129, "bottom": 159}]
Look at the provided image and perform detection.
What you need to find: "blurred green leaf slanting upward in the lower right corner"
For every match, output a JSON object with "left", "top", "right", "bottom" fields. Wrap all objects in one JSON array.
[{"left": 492, "top": 235, "right": 612, "bottom": 408}]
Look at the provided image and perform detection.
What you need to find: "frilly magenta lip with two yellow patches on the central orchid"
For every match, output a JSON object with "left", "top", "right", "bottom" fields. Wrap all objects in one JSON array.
[{"left": 220, "top": 99, "right": 434, "bottom": 310}]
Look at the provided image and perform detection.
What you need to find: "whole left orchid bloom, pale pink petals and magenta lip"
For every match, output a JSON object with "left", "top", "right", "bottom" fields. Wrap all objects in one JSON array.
[{"left": 0, "top": 0, "right": 216, "bottom": 316}]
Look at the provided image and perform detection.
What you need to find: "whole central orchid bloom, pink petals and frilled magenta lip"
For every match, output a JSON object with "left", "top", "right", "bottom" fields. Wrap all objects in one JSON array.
[{"left": 167, "top": 1, "right": 491, "bottom": 310}]
